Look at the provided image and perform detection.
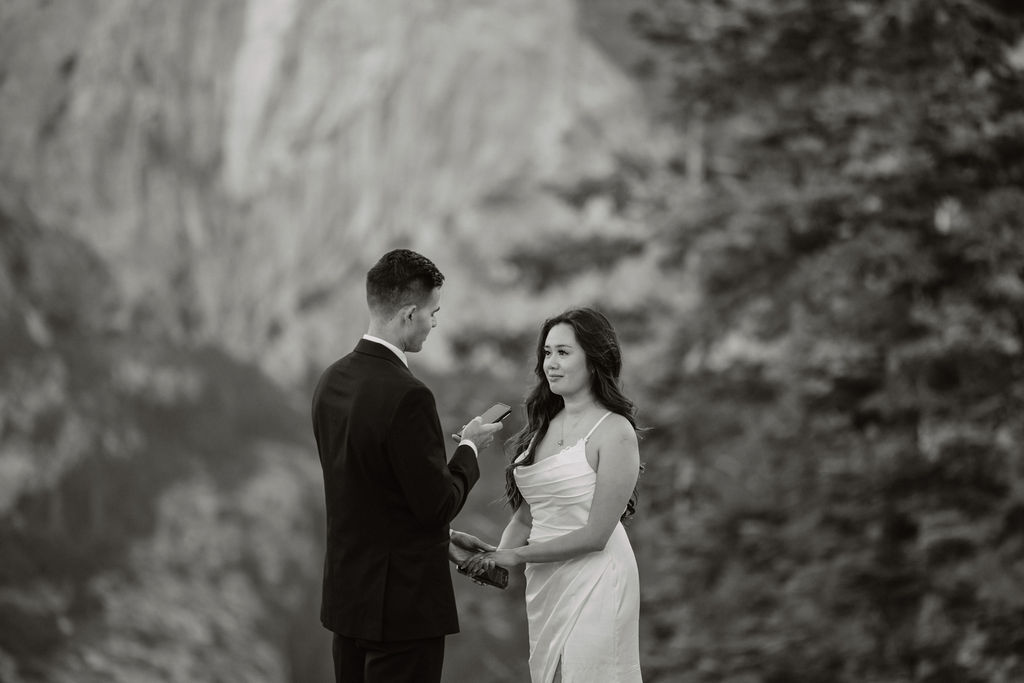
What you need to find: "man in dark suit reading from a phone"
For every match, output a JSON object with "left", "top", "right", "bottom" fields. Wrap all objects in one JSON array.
[{"left": 312, "top": 249, "right": 501, "bottom": 683}]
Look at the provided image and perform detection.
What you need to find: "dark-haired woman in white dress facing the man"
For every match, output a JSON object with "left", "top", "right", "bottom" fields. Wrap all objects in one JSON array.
[{"left": 467, "top": 308, "right": 641, "bottom": 683}]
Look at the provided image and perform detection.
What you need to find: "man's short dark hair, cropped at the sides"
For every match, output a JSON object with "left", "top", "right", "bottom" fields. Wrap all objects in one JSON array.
[{"left": 367, "top": 249, "right": 444, "bottom": 317}]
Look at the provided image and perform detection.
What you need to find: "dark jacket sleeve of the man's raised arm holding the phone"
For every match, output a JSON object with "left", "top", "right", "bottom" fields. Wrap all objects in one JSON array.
[{"left": 387, "top": 387, "right": 480, "bottom": 524}]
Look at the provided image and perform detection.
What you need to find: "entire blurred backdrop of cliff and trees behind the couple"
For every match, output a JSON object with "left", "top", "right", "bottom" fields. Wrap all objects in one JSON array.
[{"left": 0, "top": 0, "right": 1024, "bottom": 683}]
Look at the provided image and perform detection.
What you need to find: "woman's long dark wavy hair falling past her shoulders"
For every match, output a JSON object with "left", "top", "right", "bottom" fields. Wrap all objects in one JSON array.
[{"left": 505, "top": 308, "right": 643, "bottom": 519}]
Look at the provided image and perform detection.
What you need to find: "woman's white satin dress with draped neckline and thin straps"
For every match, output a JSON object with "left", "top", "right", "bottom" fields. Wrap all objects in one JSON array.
[{"left": 514, "top": 413, "right": 641, "bottom": 683}]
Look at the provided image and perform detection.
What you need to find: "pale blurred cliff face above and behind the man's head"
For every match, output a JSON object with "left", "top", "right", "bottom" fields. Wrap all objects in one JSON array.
[{"left": 0, "top": 0, "right": 647, "bottom": 381}]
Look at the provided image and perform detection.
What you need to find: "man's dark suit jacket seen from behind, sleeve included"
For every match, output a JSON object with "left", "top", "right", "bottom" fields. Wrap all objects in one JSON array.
[{"left": 312, "top": 339, "right": 480, "bottom": 641}]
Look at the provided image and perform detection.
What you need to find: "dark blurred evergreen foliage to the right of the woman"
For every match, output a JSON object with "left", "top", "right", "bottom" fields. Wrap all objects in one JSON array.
[{"left": 610, "top": 0, "right": 1024, "bottom": 683}]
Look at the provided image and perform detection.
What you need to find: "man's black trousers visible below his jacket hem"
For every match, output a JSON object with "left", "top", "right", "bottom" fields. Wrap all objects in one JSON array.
[{"left": 333, "top": 634, "right": 444, "bottom": 683}]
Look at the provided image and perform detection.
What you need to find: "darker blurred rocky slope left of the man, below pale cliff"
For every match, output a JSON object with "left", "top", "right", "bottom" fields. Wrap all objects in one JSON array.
[{"left": 0, "top": 213, "right": 329, "bottom": 683}]
